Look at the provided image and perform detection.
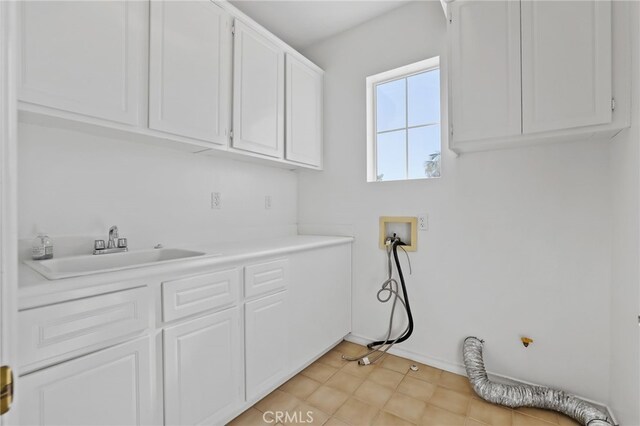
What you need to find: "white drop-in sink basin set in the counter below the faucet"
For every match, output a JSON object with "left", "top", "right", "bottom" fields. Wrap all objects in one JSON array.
[{"left": 25, "top": 248, "right": 220, "bottom": 280}]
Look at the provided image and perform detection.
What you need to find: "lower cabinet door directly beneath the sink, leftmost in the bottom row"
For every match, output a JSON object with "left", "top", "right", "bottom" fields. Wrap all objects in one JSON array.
[{"left": 18, "top": 337, "right": 153, "bottom": 426}]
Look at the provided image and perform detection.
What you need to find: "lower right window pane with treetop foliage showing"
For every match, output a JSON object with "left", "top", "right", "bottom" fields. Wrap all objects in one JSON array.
[{"left": 409, "top": 125, "right": 440, "bottom": 179}]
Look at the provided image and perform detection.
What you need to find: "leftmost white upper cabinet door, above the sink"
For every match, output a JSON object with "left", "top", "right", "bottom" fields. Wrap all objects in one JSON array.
[{"left": 18, "top": 1, "right": 149, "bottom": 125}]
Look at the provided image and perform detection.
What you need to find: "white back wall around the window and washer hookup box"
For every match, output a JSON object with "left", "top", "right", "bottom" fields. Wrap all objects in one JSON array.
[{"left": 298, "top": 2, "right": 611, "bottom": 402}]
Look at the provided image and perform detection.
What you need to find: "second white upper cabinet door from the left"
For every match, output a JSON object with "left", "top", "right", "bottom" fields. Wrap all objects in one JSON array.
[{"left": 149, "top": 0, "right": 233, "bottom": 145}]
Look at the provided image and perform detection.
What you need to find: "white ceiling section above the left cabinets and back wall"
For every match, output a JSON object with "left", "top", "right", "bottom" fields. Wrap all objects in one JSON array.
[{"left": 230, "top": 0, "right": 408, "bottom": 50}]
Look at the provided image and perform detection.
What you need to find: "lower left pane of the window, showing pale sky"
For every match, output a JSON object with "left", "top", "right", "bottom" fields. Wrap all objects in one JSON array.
[{"left": 376, "top": 130, "right": 407, "bottom": 181}]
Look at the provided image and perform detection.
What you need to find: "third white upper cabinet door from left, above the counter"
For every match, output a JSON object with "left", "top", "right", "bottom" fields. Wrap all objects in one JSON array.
[{"left": 232, "top": 19, "right": 284, "bottom": 158}]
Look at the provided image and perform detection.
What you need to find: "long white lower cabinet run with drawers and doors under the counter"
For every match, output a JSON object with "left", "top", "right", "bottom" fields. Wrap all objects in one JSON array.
[{"left": 16, "top": 244, "right": 351, "bottom": 426}]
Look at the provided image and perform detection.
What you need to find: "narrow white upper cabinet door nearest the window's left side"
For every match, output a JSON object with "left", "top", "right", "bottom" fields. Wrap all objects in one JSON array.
[{"left": 285, "top": 54, "right": 322, "bottom": 167}]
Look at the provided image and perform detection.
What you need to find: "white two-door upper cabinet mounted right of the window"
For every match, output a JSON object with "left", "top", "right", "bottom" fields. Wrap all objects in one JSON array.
[{"left": 449, "top": 0, "right": 630, "bottom": 152}]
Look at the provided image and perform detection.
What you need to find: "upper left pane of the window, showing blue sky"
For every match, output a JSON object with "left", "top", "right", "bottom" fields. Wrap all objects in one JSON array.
[{"left": 376, "top": 79, "right": 406, "bottom": 132}]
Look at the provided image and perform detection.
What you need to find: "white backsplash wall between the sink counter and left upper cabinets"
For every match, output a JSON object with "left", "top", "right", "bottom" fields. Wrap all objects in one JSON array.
[{"left": 18, "top": 124, "right": 297, "bottom": 256}]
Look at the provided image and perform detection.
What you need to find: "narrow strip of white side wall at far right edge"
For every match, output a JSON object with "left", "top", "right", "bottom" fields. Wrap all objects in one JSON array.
[{"left": 610, "top": 2, "right": 640, "bottom": 425}]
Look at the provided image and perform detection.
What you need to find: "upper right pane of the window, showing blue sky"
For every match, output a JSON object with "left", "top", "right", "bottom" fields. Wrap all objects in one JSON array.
[{"left": 407, "top": 69, "right": 440, "bottom": 126}]
